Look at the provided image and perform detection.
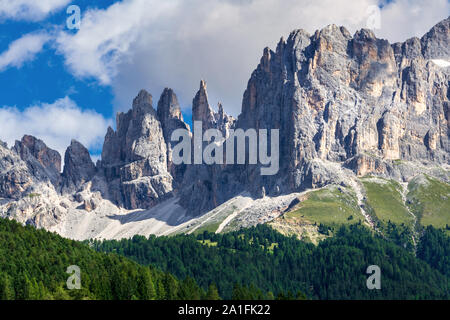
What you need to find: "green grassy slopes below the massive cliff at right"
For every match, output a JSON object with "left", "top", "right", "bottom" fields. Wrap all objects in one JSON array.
[{"left": 270, "top": 176, "right": 450, "bottom": 243}]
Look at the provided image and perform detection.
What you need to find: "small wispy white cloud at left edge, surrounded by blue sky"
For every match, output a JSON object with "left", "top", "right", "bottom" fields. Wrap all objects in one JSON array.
[{"left": 0, "top": 33, "right": 50, "bottom": 71}]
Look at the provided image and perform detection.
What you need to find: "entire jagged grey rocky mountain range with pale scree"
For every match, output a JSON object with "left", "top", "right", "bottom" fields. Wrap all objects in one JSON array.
[{"left": 0, "top": 18, "right": 450, "bottom": 238}]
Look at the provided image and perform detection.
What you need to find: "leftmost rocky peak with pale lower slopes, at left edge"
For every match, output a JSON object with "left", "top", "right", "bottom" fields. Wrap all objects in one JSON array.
[{"left": 0, "top": 136, "right": 63, "bottom": 228}]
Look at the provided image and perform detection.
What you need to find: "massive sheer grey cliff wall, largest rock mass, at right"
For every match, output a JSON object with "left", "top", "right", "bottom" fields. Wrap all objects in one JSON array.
[{"left": 237, "top": 19, "right": 450, "bottom": 192}]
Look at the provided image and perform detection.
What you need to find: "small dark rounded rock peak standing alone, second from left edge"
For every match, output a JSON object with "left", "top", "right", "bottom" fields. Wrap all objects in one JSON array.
[{"left": 62, "top": 140, "right": 96, "bottom": 193}]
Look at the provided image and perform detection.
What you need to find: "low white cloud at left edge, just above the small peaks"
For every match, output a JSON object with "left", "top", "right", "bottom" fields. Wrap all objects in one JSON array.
[{"left": 0, "top": 97, "right": 112, "bottom": 156}]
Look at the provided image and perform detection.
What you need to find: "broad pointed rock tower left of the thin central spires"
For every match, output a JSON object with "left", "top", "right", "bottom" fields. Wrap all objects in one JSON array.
[{"left": 100, "top": 90, "right": 172, "bottom": 209}]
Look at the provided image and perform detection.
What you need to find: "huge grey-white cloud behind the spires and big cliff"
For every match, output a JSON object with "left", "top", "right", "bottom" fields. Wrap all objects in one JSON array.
[{"left": 51, "top": 0, "right": 449, "bottom": 115}]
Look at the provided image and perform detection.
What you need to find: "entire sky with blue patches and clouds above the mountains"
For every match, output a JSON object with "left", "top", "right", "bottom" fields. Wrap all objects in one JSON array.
[{"left": 0, "top": 0, "right": 450, "bottom": 158}]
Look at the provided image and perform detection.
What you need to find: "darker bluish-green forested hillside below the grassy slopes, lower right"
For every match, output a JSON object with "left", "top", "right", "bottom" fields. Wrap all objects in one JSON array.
[{"left": 92, "top": 225, "right": 450, "bottom": 299}]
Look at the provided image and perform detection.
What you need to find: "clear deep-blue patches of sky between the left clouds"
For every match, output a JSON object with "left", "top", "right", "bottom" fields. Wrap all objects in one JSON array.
[{"left": 0, "top": 0, "right": 114, "bottom": 117}]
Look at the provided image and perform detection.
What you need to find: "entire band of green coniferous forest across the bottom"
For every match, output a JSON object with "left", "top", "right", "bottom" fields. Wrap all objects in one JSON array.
[{"left": 0, "top": 215, "right": 450, "bottom": 300}]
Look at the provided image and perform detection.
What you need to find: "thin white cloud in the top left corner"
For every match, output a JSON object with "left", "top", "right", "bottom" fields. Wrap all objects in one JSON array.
[{"left": 0, "top": 0, "right": 70, "bottom": 21}]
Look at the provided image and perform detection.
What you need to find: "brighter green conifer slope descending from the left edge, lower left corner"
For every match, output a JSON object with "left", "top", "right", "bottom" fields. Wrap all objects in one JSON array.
[{"left": 0, "top": 219, "right": 207, "bottom": 300}]
